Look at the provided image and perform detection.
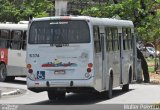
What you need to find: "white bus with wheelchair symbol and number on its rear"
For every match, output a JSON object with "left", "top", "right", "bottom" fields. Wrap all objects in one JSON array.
[{"left": 26, "top": 16, "right": 135, "bottom": 100}]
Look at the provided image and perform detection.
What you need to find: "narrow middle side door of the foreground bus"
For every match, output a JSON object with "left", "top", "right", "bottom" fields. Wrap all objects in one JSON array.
[{"left": 118, "top": 28, "right": 124, "bottom": 85}]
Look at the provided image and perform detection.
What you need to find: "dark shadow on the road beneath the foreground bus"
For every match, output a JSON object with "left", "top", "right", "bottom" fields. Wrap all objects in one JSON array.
[{"left": 28, "top": 89, "right": 133, "bottom": 105}]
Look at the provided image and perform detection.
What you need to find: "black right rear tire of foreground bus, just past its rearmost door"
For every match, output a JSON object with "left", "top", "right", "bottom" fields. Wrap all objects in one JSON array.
[{"left": 106, "top": 76, "right": 113, "bottom": 99}]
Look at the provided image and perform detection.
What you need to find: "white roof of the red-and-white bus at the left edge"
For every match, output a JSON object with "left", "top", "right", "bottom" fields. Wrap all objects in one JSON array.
[{"left": 0, "top": 24, "right": 28, "bottom": 30}]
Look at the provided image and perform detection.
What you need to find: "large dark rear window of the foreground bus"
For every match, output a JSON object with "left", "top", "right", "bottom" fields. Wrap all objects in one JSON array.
[{"left": 29, "top": 20, "right": 90, "bottom": 44}]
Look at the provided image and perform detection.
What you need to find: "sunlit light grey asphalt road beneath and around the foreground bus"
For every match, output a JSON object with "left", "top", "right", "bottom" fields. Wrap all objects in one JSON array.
[{"left": 0, "top": 78, "right": 160, "bottom": 110}]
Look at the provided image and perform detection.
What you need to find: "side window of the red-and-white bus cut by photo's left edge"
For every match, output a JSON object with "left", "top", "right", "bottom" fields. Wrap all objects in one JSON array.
[{"left": 0, "top": 30, "right": 10, "bottom": 48}]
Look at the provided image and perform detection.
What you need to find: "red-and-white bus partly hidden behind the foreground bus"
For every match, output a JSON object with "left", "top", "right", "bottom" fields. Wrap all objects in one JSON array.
[{"left": 0, "top": 24, "right": 28, "bottom": 82}]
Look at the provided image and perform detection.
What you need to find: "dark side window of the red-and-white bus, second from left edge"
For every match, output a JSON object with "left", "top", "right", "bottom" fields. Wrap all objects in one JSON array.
[{"left": 11, "top": 30, "right": 22, "bottom": 50}]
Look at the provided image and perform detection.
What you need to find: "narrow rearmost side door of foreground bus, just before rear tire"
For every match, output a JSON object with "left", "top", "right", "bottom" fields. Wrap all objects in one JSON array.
[{"left": 100, "top": 27, "right": 106, "bottom": 90}]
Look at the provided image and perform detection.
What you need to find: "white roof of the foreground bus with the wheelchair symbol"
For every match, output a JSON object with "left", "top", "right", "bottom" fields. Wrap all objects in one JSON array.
[{"left": 33, "top": 16, "right": 134, "bottom": 27}]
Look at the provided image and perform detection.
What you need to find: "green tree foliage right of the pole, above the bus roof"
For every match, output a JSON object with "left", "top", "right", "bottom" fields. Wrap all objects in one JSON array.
[{"left": 82, "top": 0, "right": 160, "bottom": 42}]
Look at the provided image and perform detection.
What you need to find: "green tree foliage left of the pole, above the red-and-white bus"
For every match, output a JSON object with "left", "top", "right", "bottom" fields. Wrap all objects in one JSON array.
[{"left": 0, "top": 0, "right": 53, "bottom": 22}]
